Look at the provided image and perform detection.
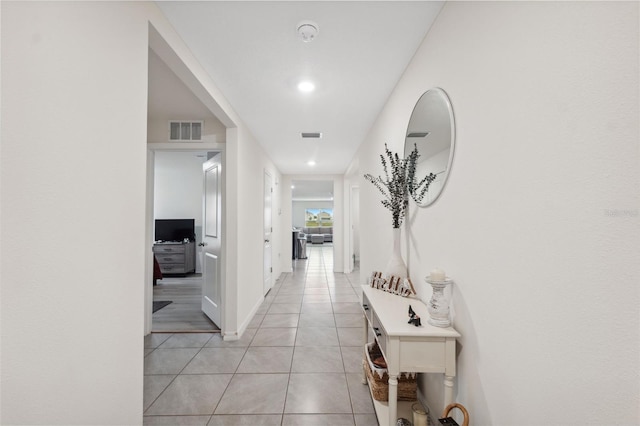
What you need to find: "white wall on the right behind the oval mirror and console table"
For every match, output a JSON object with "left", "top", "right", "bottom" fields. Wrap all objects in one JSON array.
[{"left": 356, "top": 2, "right": 640, "bottom": 425}]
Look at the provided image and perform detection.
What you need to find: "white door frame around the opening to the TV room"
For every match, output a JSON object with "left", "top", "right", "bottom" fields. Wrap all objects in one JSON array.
[{"left": 144, "top": 142, "right": 227, "bottom": 335}]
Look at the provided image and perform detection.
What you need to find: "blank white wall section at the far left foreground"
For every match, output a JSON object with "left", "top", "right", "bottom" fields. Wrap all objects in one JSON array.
[{"left": 0, "top": 2, "right": 148, "bottom": 425}]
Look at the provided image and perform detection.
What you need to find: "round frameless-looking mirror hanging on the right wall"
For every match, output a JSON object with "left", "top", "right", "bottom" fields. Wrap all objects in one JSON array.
[{"left": 404, "top": 88, "right": 455, "bottom": 207}]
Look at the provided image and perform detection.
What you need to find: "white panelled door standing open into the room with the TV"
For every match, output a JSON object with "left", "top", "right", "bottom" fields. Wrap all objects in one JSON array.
[{"left": 202, "top": 153, "right": 222, "bottom": 329}]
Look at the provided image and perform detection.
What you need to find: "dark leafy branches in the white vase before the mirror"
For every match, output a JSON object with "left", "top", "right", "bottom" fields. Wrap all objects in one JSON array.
[{"left": 364, "top": 144, "right": 436, "bottom": 228}]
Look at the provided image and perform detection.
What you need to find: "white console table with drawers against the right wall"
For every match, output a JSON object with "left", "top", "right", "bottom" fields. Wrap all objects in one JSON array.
[{"left": 362, "top": 285, "right": 460, "bottom": 426}]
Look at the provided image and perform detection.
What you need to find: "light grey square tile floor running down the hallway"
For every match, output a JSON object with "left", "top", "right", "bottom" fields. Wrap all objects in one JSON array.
[{"left": 144, "top": 246, "right": 378, "bottom": 426}]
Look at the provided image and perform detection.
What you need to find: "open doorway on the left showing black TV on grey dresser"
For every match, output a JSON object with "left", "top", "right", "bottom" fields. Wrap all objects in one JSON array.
[{"left": 151, "top": 150, "right": 219, "bottom": 332}]
